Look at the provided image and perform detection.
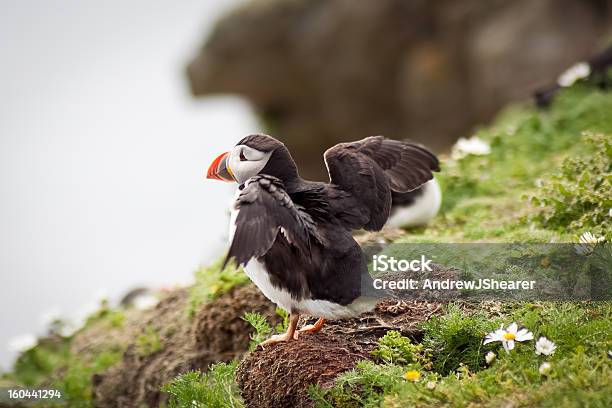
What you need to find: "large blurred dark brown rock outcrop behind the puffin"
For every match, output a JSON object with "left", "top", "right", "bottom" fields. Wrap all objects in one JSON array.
[{"left": 188, "top": 0, "right": 612, "bottom": 177}]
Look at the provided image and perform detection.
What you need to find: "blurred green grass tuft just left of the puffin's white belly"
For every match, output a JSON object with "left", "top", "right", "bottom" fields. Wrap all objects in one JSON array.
[{"left": 187, "top": 258, "right": 249, "bottom": 316}]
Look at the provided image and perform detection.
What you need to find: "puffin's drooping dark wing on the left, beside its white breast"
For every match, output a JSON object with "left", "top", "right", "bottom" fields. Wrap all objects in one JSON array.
[{"left": 223, "top": 175, "right": 316, "bottom": 267}]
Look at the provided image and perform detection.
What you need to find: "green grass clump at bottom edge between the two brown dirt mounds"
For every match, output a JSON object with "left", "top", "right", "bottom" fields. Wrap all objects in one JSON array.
[{"left": 162, "top": 361, "right": 243, "bottom": 408}]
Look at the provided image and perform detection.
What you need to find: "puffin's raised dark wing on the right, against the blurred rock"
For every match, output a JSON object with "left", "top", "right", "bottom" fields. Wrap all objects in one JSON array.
[{"left": 324, "top": 136, "right": 440, "bottom": 230}]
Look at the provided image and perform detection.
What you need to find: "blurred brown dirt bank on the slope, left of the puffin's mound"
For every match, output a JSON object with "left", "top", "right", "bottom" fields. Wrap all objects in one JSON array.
[{"left": 93, "top": 285, "right": 276, "bottom": 408}]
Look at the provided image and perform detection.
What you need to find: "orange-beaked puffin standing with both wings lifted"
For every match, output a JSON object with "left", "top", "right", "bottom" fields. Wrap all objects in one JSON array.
[{"left": 206, "top": 134, "right": 440, "bottom": 346}]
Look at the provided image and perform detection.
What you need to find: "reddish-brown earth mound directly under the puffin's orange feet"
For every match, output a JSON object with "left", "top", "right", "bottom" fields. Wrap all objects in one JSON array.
[{"left": 236, "top": 300, "right": 441, "bottom": 408}]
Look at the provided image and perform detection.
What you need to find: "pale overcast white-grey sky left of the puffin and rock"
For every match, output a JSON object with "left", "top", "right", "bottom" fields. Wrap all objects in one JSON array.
[{"left": 0, "top": 0, "right": 258, "bottom": 368}]
